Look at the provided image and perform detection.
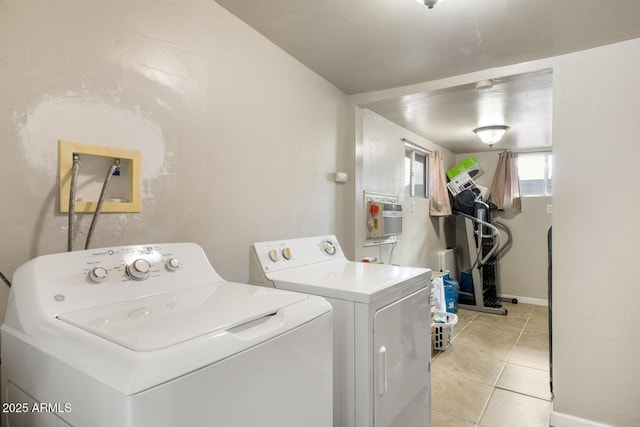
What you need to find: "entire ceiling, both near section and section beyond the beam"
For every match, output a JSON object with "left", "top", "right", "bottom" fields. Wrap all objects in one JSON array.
[{"left": 217, "top": 0, "right": 640, "bottom": 152}]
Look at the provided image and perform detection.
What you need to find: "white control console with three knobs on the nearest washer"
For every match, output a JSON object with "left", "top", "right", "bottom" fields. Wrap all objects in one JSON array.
[{"left": 5, "top": 243, "right": 223, "bottom": 335}]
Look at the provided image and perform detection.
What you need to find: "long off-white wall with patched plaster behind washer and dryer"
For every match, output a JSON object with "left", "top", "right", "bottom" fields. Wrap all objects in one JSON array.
[{"left": 0, "top": 0, "right": 351, "bottom": 318}]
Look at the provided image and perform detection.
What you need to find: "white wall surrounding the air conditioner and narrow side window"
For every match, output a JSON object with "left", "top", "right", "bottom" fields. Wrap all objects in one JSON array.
[{"left": 355, "top": 109, "right": 455, "bottom": 270}]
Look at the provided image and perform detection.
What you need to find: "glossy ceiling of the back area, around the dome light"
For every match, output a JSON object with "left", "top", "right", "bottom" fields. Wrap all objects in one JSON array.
[{"left": 364, "top": 70, "right": 553, "bottom": 153}]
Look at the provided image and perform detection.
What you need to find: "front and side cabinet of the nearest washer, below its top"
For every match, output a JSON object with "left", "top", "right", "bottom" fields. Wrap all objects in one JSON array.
[{"left": 2, "top": 313, "right": 332, "bottom": 427}]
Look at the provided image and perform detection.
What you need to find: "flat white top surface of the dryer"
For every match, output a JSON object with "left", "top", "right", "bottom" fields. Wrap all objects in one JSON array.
[{"left": 266, "top": 259, "right": 431, "bottom": 304}]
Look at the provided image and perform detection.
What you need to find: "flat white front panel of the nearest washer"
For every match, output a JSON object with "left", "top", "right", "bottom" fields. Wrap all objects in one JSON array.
[{"left": 132, "top": 315, "right": 333, "bottom": 427}]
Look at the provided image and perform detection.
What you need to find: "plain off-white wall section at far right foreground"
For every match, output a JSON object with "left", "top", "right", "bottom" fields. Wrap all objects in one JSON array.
[{"left": 553, "top": 39, "right": 640, "bottom": 426}]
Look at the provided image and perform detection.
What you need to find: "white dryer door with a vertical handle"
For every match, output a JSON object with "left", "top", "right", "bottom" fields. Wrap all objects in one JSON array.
[{"left": 373, "top": 288, "right": 431, "bottom": 427}]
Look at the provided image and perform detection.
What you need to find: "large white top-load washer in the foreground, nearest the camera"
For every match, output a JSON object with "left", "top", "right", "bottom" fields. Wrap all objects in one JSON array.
[{"left": 1, "top": 243, "right": 332, "bottom": 427}]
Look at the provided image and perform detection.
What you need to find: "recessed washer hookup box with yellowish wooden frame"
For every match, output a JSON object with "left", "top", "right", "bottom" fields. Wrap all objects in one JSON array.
[{"left": 58, "top": 141, "right": 142, "bottom": 212}]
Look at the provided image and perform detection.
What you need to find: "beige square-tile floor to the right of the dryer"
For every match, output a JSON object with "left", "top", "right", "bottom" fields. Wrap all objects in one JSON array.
[{"left": 431, "top": 303, "right": 552, "bottom": 427}]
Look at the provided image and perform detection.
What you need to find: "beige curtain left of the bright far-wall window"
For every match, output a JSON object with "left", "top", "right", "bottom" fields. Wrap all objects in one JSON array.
[{"left": 489, "top": 151, "right": 522, "bottom": 213}]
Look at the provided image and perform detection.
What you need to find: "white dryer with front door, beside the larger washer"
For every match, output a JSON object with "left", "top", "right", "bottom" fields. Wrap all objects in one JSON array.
[{"left": 250, "top": 236, "right": 431, "bottom": 427}]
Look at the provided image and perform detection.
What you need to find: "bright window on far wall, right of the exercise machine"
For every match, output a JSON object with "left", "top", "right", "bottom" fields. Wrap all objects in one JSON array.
[{"left": 518, "top": 152, "right": 553, "bottom": 197}]
